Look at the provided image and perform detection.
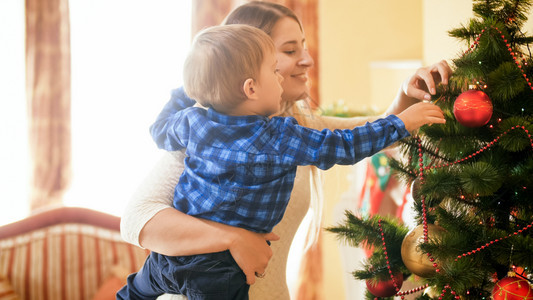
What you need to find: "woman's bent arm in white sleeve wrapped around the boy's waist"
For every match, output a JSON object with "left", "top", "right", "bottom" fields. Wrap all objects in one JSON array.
[{"left": 120, "top": 151, "right": 279, "bottom": 284}]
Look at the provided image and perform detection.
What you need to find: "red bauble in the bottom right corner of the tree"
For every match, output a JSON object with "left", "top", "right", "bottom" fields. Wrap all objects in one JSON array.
[{"left": 492, "top": 272, "right": 533, "bottom": 300}]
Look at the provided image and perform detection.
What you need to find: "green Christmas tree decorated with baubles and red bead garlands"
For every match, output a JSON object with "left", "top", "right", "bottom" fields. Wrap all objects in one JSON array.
[{"left": 327, "top": 0, "right": 533, "bottom": 300}]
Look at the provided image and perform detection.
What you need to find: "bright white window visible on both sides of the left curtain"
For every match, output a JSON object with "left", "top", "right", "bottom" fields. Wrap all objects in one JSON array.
[{"left": 0, "top": 0, "right": 191, "bottom": 224}]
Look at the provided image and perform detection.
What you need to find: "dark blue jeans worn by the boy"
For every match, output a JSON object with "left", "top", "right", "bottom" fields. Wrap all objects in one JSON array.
[{"left": 117, "top": 250, "right": 250, "bottom": 300}]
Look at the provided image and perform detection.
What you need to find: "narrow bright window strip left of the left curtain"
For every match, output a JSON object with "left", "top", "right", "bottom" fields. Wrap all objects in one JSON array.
[{"left": 0, "top": 0, "right": 29, "bottom": 224}]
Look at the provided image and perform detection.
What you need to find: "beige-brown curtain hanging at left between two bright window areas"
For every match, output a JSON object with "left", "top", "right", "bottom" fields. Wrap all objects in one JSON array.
[{"left": 26, "top": 0, "right": 71, "bottom": 211}]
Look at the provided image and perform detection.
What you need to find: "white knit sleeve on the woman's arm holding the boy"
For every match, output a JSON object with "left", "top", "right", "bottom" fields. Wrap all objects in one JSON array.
[{"left": 120, "top": 151, "right": 185, "bottom": 247}]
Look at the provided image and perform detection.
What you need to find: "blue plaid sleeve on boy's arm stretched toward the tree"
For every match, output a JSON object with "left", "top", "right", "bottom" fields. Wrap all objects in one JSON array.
[{"left": 280, "top": 115, "right": 409, "bottom": 170}]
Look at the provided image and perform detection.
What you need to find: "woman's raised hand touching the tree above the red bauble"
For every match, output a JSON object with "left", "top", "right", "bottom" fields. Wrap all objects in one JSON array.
[{"left": 402, "top": 60, "right": 452, "bottom": 100}]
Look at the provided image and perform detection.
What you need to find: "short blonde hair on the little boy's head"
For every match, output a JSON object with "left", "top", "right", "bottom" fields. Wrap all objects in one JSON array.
[{"left": 183, "top": 24, "right": 275, "bottom": 112}]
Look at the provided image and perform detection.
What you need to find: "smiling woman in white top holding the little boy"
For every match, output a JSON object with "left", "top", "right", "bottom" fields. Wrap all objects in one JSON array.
[{"left": 121, "top": 2, "right": 451, "bottom": 299}]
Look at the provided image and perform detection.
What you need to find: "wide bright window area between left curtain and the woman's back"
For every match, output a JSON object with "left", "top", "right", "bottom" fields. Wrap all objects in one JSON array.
[{"left": 65, "top": 0, "right": 191, "bottom": 214}]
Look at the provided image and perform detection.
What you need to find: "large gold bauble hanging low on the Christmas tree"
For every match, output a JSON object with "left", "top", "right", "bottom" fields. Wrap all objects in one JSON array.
[{"left": 401, "top": 224, "right": 444, "bottom": 278}]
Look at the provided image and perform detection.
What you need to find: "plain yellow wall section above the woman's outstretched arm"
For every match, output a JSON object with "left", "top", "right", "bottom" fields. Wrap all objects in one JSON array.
[{"left": 319, "top": 0, "right": 422, "bottom": 109}]
